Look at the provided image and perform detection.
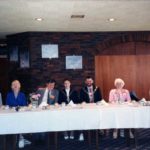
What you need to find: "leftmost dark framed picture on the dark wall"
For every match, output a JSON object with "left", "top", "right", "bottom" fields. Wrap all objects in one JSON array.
[{"left": 9, "top": 46, "right": 19, "bottom": 62}]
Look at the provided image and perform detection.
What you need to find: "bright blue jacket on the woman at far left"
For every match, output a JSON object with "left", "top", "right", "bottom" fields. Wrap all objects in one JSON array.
[{"left": 6, "top": 91, "right": 27, "bottom": 107}]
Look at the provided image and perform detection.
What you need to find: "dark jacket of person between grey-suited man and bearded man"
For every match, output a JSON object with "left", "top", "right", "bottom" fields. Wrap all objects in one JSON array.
[{"left": 58, "top": 88, "right": 79, "bottom": 104}]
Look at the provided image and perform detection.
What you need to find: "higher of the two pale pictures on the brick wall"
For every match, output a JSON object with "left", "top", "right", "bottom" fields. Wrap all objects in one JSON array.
[{"left": 41, "top": 44, "right": 58, "bottom": 59}]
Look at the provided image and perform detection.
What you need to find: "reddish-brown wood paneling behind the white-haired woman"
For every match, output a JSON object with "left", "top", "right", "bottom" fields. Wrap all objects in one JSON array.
[{"left": 95, "top": 55, "right": 150, "bottom": 99}]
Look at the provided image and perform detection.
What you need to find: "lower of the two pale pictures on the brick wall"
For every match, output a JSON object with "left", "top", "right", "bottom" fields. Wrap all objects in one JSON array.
[{"left": 66, "top": 55, "right": 83, "bottom": 69}]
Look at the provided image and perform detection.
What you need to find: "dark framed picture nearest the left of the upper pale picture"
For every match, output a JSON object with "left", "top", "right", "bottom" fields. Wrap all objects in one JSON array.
[{"left": 20, "top": 51, "right": 30, "bottom": 68}]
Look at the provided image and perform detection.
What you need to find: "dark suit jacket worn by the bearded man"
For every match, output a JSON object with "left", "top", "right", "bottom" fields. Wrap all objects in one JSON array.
[{"left": 80, "top": 85, "right": 102, "bottom": 103}]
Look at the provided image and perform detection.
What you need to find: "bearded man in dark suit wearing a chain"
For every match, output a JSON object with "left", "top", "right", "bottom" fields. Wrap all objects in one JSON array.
[{"left": 80, "top": 77, "right": 102, "bottom": 103}]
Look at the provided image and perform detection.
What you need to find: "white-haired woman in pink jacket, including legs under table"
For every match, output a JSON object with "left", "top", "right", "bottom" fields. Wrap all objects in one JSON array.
[{"left": 109, "top": 78, "right": 134, "bottom": 139}]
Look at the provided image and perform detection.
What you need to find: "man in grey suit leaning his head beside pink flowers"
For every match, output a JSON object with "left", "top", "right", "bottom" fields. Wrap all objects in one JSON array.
[{"left": 36, "top": 79, "right": 59, "bottom": 106}]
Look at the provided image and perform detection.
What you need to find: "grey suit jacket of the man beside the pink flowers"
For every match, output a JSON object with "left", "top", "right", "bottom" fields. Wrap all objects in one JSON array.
[{"left": 36, "top": 88, "right": 59, "bottom": 105}]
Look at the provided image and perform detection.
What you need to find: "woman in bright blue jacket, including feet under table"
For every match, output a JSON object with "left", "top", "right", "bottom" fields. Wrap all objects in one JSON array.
[{"left": 6, "top": 80, "right": 31, "bottom": 148}]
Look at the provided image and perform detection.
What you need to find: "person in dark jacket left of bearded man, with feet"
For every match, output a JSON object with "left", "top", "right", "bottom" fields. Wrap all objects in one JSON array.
[{"left": 58, "top": 79, "right": 79, "bottom": 140}]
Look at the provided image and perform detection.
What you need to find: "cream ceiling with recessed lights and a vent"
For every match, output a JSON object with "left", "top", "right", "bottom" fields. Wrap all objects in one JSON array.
[{"left": 0, "top": 0, "right": 150, "bottom": 38}]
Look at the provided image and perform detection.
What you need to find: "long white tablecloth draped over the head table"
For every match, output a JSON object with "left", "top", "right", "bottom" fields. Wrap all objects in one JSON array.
[{"left": 0, "top": 104, "right": 150, "bottom": 134}]
